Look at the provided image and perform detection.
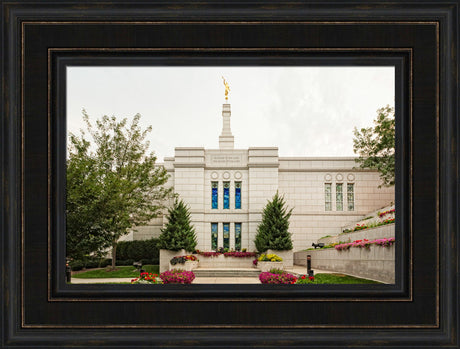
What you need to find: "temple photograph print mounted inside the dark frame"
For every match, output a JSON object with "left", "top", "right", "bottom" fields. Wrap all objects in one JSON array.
[{"left": 66, "top": 65, "right": 398, "bottom": 284}]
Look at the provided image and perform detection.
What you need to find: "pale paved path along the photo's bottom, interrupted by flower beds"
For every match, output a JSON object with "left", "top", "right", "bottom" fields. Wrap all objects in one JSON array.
[{"left": 72, "top": 265, "right": 334, "bottom": 284}]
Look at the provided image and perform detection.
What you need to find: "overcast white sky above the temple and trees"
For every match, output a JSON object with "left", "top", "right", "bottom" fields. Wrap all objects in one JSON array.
[{"left": 67, "top": 67, "right": 395, "bottom": 162}]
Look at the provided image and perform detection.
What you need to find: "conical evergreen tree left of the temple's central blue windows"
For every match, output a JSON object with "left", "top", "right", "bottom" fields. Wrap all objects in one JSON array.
[{"left": 158, "top": 199, "right": 197, "bottom": 252}]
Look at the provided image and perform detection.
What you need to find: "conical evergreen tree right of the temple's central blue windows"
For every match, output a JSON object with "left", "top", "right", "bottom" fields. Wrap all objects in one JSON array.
[{"left": 254, "top": 192, "right": 292, "bottom": 252}]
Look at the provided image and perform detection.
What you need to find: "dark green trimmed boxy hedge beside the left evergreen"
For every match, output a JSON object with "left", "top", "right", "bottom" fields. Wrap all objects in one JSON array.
[{"left": 117, "top": 239, "right": 160, "bottom": 265}]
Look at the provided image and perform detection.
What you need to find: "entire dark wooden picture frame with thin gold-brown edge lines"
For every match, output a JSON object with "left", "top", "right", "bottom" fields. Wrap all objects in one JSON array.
[{"left": 0, "top": 1, "right": 459, "bottom": 348}]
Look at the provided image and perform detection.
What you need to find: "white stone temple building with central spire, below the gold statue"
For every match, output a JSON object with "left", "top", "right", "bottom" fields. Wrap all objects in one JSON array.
[{"left": 128, "top": 94, "right": 394, "bottom": 251}]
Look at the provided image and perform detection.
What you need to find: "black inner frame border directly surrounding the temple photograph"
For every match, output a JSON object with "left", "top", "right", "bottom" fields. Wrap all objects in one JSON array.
[{"left": 48, "top": 48, "right": 413, "bottom": 301}]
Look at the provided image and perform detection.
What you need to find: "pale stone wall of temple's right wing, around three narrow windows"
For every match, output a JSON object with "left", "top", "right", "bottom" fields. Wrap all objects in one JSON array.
[{"left": 279, "top": 158, "right": 395, "bottom": 250}]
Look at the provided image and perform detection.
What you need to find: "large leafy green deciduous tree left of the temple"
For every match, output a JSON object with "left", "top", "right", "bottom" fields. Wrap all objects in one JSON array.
[{"left": 66, "top": 110, "right": 173, "bottom": 268}]
